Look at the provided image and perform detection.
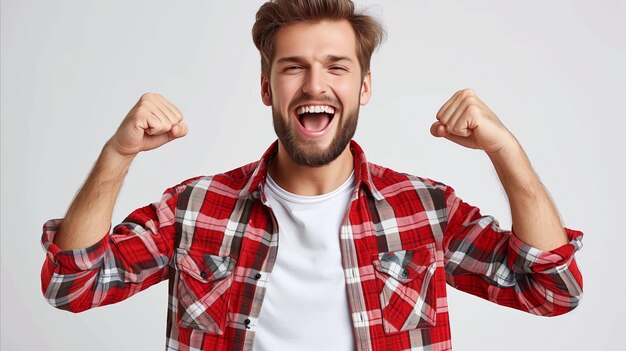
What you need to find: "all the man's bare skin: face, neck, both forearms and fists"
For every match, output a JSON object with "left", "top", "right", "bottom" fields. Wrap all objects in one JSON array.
[{"left": 55, "top": 21, "right": 567, "bottom": 250}]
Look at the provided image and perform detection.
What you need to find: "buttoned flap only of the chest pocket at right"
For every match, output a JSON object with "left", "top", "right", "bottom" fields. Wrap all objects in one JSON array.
[{"left": 372, "top": 243, "right": 435, "bottom": 283}]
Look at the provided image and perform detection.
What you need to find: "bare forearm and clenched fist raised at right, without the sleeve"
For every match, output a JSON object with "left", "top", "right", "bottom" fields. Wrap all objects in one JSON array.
[{"left": 431, "top": 89, "right": 568, "bottom": 251}]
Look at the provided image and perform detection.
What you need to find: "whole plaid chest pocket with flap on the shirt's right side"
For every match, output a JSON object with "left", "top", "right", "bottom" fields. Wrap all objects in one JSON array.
[{"left": 372, "top": 243, "right": 437, "bottom": 333}]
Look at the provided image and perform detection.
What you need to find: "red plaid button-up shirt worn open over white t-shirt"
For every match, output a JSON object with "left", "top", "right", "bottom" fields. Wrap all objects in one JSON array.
[{"left": 41, "top": 141, "right": 582, "bottom": 351}]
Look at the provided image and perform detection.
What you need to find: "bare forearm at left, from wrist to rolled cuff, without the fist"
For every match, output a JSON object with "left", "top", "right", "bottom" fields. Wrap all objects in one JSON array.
[{"left": 54, "top": 143, "right": 133, "bottom": 250}]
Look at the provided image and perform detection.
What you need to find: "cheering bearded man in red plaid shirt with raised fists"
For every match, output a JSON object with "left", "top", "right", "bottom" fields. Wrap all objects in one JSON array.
[{"left": 42, "top": 0, "right": 582, "bottom": 350}]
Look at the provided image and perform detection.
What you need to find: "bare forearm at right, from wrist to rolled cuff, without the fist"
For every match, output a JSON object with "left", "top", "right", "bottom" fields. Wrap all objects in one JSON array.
[{"left": 488, "top": 140, "right": 568, "bottom": 251}]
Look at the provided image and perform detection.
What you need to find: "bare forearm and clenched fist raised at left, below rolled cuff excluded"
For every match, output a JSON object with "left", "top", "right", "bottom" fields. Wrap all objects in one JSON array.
[{"left": 54, "top": 94, "right": 187, "bottom": 250}]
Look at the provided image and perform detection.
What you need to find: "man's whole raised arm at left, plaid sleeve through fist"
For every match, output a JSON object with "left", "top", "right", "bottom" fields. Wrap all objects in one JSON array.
[{"left": 41, "top": 94, "right": 191, "bottom": 312}]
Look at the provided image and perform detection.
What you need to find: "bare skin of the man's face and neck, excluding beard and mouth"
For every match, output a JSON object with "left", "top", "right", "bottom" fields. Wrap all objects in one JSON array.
[{"left": 261, "top": 21, "right": 371, "bottom": 195}]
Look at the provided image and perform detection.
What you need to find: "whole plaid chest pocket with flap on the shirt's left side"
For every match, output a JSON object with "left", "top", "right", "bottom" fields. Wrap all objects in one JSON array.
[{"left": 175, "top": 248, "right": 235, "bottom": 334}]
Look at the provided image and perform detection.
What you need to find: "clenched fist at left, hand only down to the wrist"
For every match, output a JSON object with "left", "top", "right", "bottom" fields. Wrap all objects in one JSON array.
[{"left": 109, "top": 93, "right": 187, "bottom": 156}]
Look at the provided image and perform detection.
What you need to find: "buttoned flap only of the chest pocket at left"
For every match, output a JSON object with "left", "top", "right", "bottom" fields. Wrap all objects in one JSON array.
[{"left": 175, "top": 248, "right": 235, "bottom": 283}]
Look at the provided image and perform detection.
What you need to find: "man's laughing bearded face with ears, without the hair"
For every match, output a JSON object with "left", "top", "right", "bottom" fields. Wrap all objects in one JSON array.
[{"left": 261, "top": 21, "right": 371, "bottom": 167}]
